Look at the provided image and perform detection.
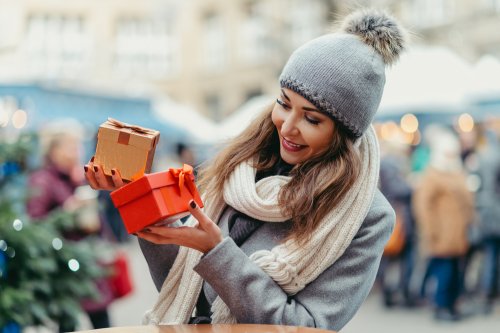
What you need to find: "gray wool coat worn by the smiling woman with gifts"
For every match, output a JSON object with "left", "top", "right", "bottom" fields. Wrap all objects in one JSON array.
[{"left": 139, "top": 190, "right": 395, "bottom": 331}]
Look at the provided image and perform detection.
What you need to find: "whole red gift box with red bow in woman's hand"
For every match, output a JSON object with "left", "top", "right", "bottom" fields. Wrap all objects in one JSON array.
[{"left": 111, "top": 164, "right": 203, "bottom": 234}]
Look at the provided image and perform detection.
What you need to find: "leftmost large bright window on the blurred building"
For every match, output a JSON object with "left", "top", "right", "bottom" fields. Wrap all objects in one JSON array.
[{"left": 24, "top": 14, "right": 90, "bottom": 78}]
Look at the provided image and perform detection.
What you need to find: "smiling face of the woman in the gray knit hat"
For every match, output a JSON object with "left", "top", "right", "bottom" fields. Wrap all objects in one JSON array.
[{"left": 272, "top": 89, "right": 335, "bottom": 165}]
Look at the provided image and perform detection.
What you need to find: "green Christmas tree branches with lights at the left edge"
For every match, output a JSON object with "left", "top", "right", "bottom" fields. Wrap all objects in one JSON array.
[{"left": 0, "top": 134, "right": 106, "bottom": 328}]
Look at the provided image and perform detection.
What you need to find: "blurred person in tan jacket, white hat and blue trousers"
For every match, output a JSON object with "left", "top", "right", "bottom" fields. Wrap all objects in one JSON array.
[{"left": 412, "top": 128, "right": 474, "bottom": 321}]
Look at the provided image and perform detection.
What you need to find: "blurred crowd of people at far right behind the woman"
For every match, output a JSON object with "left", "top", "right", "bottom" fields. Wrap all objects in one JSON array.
[{"left": 377, "top": 122, "right": 500, "bottom": 321}]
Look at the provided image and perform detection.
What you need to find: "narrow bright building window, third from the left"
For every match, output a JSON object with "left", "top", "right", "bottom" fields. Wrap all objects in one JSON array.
[{"left": 201, "top": 13, "right": 228, "bottom": 72}]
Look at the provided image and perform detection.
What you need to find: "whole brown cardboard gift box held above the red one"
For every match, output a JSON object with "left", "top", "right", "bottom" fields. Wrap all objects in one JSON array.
[{"left": 94, "top": 118, "right": 160, "bottom": 181}]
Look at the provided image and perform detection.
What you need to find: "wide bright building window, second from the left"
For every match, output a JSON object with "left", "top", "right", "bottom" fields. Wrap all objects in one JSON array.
[{"left": 114, "top": 19, "right": 180, "bottom": 78}]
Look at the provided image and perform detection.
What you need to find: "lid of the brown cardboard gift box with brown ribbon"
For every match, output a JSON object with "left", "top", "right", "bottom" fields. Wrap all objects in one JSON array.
[{"left": 97, "top": 118, "right": 160, "bottom": 150}]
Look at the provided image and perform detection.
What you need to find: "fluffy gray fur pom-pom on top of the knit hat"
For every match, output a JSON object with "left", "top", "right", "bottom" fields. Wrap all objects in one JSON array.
[{"left": 341, "top": 10, "right": 406, "bottom": 65}]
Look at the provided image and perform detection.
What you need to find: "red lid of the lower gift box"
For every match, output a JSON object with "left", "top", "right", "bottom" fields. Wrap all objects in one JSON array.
[{"left": 111, "top": 171, "right": 194, "bottom": 208}]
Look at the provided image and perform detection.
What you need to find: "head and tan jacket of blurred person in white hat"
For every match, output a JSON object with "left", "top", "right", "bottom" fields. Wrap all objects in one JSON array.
[{"left": 413, "top": 129, "right": 475, "bottom": 258}]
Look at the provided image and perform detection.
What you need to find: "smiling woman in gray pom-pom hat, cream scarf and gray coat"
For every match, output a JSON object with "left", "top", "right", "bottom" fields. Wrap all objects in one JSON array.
[{"left": 86, "top": 12, "right": 404, "bottom": 330}]
